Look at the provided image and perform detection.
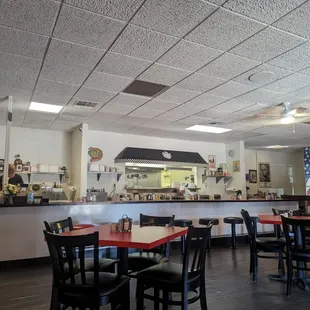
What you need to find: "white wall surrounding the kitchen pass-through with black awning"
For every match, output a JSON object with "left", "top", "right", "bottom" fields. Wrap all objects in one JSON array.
[{"left": 85, "top": 130, "right": 226, "bottom": 194}]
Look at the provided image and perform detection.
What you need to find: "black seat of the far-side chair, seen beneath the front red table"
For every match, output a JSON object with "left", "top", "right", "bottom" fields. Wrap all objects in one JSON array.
[{"left": 128, "top": 252, "right": 168, "bottom": 271}]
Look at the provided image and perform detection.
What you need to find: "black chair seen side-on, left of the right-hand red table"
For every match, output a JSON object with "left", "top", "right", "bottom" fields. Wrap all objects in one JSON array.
[{"left": 241, "top": 209, "right": 286, "bottom": 282}]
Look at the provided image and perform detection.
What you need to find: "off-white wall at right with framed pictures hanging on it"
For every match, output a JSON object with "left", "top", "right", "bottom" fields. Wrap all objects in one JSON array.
[{"left": 245, "top": 149, "right": 305, "bottom": 195}]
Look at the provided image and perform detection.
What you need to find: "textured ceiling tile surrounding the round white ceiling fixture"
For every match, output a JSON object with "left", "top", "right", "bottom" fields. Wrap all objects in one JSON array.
[{"left": 233, "top": 64, "right": 293, "bottom": 87}]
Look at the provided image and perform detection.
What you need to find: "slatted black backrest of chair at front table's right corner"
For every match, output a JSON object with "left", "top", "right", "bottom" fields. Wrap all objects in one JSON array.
[{"left": 183, "top": 223, "right": 212, "bottom": 283}]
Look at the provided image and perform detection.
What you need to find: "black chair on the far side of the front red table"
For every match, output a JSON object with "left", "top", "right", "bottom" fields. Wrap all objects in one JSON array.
[{"left": 128, "top": 214, "right": 174, "bottom": 278}]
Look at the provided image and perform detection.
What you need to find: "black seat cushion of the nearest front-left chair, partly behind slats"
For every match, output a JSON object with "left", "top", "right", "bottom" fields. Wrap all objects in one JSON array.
[{"left": 66, "top": 272, "right": 130, "bottom": 296}]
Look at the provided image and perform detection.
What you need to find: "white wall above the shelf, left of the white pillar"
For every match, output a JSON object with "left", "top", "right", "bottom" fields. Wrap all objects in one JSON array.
[{"left": 0, "top": 126, "right": 68, "bottom": 182}]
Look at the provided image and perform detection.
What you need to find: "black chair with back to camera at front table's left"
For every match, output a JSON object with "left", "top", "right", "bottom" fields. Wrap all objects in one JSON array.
[{"left": 44, "top": 230, "right": 130, "bottom": 310}]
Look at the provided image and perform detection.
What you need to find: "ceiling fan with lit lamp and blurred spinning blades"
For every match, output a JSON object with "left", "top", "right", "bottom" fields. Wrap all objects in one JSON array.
[{"left": 241, "top": 102, "right": 310, "bottom": 126}]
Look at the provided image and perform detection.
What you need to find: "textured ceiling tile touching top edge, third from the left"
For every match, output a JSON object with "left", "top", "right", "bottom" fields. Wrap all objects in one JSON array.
[{"left": 132, "top": 0, "right": 216, "bottom": 37}]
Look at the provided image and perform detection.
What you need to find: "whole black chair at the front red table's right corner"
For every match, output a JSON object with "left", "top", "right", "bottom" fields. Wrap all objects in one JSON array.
[{"left": 137, "top": 224, "right": 212, "bottom": 310}]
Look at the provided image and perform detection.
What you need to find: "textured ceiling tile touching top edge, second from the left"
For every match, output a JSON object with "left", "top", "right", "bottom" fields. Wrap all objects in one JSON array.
[{"left": 64, "top": 0, "right": 143, "bottom": 21}]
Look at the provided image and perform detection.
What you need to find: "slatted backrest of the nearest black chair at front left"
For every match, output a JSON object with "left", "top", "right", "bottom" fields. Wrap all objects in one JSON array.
[{"left": 44, "top": 230, "right": 99, "bottom": 308}]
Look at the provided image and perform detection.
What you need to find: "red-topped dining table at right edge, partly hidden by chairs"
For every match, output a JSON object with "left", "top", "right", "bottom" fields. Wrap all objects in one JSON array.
[{"left": 258, "top": 214, "right": 310, "bottom": 290}]
